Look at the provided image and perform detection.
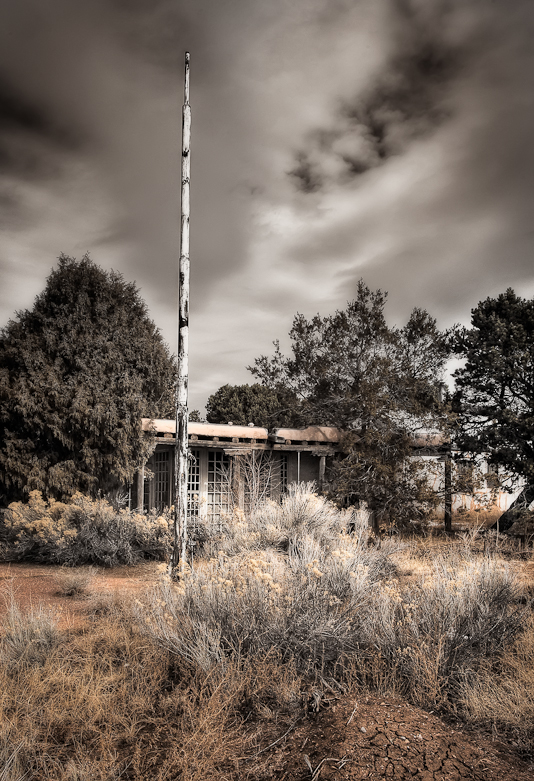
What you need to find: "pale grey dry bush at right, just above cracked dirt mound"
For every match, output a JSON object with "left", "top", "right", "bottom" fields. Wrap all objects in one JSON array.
[{"left": 356, "top": 549, "right": 526, "bottom": 707}]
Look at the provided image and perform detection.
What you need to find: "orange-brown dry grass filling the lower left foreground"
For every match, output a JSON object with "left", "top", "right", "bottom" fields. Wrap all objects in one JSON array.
[{"left": 0, "top": 584, "right": 302, "bottom": 781}]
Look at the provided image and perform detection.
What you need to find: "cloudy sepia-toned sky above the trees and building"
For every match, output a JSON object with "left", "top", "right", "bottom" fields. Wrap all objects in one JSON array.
[{"left": 0, "top": 0, "right": 534, "bottom": 409}]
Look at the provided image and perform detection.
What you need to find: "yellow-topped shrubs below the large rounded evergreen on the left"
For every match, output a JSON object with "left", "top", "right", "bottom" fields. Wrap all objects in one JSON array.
[{"left": 0, "top": 491, "right": 171, "bottom": 567}]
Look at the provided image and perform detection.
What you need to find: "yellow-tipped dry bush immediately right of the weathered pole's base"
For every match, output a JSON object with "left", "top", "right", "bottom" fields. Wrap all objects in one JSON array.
[{"left": 139, "top": 516, "right": 408, "bottom": 672}]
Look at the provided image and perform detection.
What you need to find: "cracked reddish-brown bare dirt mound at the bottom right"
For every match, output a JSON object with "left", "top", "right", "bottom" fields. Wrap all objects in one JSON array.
[{"left": 255, "top": 696, "right": 534, "bottom": 781}]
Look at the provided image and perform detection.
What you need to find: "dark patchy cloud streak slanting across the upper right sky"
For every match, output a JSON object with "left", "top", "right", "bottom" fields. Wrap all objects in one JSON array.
[{"left": 289, "top": 0, "right": 468, "bottom": 193}]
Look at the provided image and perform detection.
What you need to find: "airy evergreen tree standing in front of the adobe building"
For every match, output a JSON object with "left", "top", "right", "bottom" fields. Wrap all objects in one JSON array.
[{"left": 250, "top": 281, "right": 449, "bottom": 525}]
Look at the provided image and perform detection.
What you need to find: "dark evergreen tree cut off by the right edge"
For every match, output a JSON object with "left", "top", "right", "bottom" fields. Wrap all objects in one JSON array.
[{"left": 454, "top": 288, "right": 534, "bottom": 529}]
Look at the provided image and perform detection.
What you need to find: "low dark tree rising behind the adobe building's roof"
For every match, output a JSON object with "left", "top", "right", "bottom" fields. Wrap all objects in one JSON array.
[{"left": 206, "top": 383, "right": 294, "bottom": 429}]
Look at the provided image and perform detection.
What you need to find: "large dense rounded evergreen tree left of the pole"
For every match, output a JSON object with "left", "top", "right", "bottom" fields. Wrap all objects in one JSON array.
[{"left": 0, "top": 256, "right": 174, "bottom": 502}]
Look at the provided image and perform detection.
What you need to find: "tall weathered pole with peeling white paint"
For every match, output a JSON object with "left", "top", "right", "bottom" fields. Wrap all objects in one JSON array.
[{"left": 170, "top": 52, "right": 191, "bottom": 575}]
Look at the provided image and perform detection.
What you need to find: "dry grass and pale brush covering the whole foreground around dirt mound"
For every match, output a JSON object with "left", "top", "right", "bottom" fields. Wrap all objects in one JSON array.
[{"left": 0, "top": 487, "right": 534, "bottom": 781}]
